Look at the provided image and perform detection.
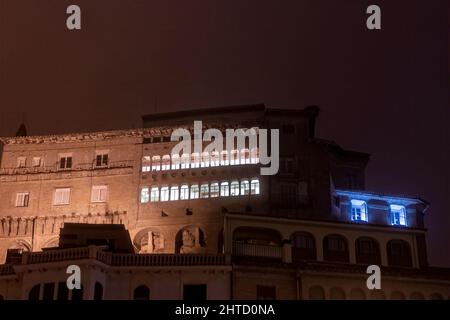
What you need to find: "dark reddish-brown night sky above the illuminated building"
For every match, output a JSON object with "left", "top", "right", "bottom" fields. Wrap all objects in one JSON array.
[{"left": 0, "top": 0, "right": 450, "bottom": 266}]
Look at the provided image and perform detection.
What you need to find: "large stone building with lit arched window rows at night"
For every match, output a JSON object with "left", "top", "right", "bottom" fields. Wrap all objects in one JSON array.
[{"left": 0, "top": 105, "right": 450, "bottom": 299}]
